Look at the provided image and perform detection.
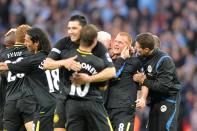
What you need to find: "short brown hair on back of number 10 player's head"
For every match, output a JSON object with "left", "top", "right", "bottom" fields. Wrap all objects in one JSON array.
[{"left": 80, "top": 24, "right": 98, "bottom": 46}]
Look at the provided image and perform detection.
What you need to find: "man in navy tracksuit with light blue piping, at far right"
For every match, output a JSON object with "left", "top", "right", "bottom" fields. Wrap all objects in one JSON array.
[{"left": 133, "top": 33, "right": 181, "bottom": 131}]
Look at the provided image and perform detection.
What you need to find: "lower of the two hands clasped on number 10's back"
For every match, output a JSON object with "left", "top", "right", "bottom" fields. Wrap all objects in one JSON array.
[{"left": 70, "top": 73, "right": 91, "bottom": 85}]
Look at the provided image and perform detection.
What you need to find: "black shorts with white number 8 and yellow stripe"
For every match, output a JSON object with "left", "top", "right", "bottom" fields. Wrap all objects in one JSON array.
[{"left": 108, "top": 108, "right": 135, "bottom": 131}]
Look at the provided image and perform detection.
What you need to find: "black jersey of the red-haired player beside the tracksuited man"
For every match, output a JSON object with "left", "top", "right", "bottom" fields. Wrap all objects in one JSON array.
[{"left": 107, "top": 57, "right": 142, "bottom": 108}]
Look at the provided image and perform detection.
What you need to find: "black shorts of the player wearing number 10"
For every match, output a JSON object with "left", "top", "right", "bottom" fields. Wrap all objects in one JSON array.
[{"left": 66, "top": 99, "right": 112, "bottom": 131}]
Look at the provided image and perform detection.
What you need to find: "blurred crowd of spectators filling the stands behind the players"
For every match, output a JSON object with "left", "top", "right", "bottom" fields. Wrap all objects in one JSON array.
[{"left": 0, "top": 0, "right": 197, "bottom": 131}]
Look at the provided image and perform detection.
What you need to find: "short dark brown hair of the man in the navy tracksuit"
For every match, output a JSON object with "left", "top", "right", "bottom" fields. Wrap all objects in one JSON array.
[{"left": 136, "top": 32, "right": 155, "bottom": 50}]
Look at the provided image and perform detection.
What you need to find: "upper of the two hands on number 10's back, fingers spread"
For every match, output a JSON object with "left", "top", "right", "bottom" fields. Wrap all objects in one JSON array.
[{"left": 63, "top": 56, "right": 81, "bottom": 72}]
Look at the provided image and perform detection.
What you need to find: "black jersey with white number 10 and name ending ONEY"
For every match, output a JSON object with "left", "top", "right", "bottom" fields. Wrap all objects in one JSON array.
[{"left": 60, "top": 49, "right": 106, "bottom": 102}]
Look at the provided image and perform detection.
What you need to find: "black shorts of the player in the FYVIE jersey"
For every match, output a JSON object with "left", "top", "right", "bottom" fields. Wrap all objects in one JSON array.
[{"left": 3, "top": 96, "right": 37, "bottom": 131}]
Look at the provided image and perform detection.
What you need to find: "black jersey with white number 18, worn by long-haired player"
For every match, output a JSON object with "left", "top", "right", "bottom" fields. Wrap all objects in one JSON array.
[{"left": 8, "top": 51, "right": 59, "bottom": 115}]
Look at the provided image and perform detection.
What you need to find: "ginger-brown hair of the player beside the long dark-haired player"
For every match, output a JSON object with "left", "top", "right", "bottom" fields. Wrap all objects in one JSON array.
[{"left": 15, "top": 25, "right": 31, "bottom": 43}]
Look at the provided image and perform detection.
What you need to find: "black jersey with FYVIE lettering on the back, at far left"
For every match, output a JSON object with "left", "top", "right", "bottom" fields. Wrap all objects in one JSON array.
[{"left": 0, "top": 45, "right": 33, "bottom": 100}]
